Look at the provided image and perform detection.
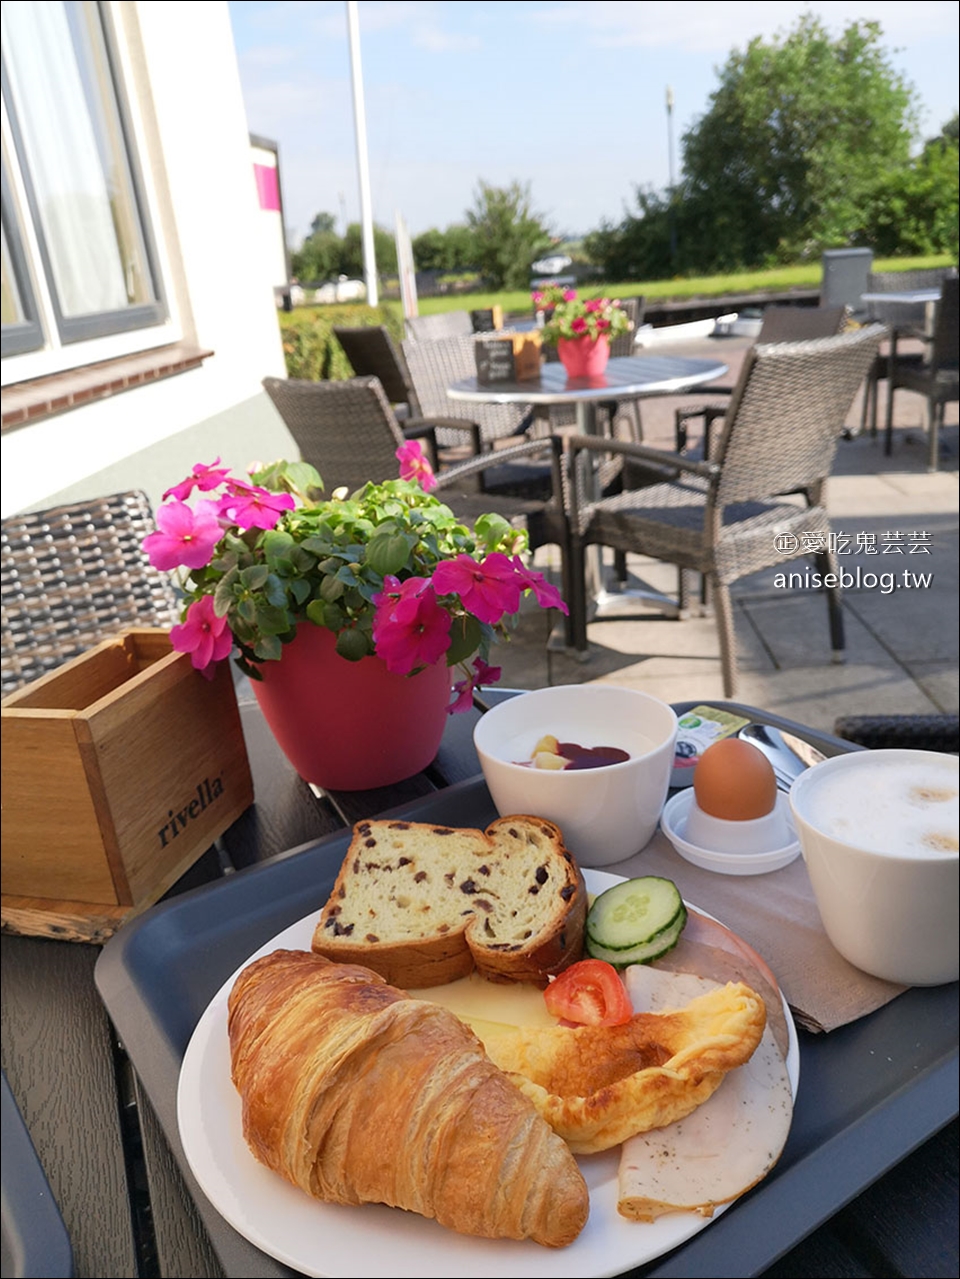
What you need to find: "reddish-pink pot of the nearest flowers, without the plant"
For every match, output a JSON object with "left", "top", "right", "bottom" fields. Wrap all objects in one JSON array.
[{"left": 252, "top": 622, "right": 451, "bottom": 790}]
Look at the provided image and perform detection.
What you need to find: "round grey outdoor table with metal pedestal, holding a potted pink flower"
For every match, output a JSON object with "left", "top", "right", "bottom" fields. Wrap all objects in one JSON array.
[{"left": 447, "top": 356, "right": 727, "bottom": 636}]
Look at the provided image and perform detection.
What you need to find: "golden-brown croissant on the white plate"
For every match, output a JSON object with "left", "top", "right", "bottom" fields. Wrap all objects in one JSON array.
[{"left": 229, "top": 950, "right": 589, "bottom": 1247}]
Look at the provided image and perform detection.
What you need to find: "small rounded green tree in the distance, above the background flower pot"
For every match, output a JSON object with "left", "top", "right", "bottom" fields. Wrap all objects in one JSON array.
[{"left": 467, "top": 179, "right": 552, "bottom": 289}]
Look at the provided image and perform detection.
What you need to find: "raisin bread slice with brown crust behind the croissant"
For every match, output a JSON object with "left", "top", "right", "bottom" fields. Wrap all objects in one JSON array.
[{"left": 313, "top": 816, "right": 587, "bottom": 989}]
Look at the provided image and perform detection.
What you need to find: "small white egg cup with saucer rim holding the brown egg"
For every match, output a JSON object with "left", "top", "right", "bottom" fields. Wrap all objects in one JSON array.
[{"left": 660, "top": 790, "right": 800, "bottom": 875}]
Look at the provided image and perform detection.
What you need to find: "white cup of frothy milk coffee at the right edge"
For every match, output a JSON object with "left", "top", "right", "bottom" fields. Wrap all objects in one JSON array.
[{"left": 790, "top": 749, "right": 960, "bottom": 986}]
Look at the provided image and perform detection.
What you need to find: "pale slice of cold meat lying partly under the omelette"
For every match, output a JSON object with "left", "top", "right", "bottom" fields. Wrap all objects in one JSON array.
[{"left": 617, "top": 966, "right": 793, "bottom": 1221}]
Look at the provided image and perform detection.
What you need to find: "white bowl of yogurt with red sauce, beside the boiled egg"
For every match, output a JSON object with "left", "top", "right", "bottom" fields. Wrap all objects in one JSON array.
[{"left": 473, "top": 684, "right": 677, "bottom": 866}]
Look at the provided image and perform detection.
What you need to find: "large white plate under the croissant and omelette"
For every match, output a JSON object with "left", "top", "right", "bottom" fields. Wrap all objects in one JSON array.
[{"left": 176, "top": 871, "right": 800, "bottom": 1279}]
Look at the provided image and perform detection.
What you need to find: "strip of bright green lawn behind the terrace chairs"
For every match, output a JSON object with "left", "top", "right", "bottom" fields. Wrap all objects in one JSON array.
[{"left": 419, "top": 255, "right": 954, "bottom": 315}]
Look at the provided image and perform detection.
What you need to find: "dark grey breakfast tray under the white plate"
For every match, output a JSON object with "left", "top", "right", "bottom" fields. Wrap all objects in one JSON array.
[{"left": 96, "top": 703, "right": 957, "bottom": 1279}]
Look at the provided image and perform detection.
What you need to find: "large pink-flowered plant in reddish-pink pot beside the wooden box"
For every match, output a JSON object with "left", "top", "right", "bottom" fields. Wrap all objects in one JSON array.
[{"left": 143, "top": 443, "right": 566, "bottom": 789}]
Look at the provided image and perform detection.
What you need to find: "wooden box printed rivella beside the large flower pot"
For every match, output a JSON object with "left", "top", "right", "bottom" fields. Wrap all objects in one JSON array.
[{"left": 1, "top": 629, "right": 253, "bottom": 940}]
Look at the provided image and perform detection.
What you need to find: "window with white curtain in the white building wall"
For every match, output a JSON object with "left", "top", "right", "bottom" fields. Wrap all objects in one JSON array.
[{"left": 3, "top": 0, "right": 166, "bottom": 356}]
